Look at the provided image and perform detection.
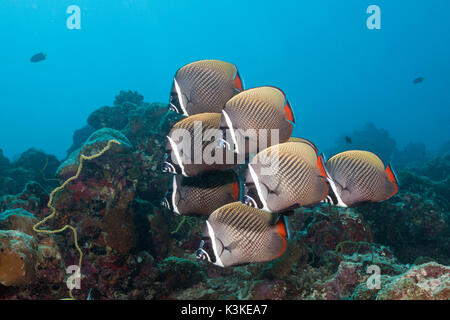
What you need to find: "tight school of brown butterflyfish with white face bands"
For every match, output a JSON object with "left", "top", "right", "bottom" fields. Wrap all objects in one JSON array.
[{"left": 162, "top": 60, "right": 398, "bottom": 267}]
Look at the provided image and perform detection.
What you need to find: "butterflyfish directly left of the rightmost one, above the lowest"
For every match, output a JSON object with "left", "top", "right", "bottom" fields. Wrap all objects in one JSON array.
[{"left": 243, "top": 139, "right": 328, "bottom": 213}]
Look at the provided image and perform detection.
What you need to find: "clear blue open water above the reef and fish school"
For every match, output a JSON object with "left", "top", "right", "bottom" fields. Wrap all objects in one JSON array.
[{"left": 0, "top": 0, "right": 450, "bottom": 158}]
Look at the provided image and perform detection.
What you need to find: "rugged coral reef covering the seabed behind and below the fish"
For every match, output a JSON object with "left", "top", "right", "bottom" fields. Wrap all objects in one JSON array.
[{"left": 0, "top": 91, "right": 450, "bottom": 300}]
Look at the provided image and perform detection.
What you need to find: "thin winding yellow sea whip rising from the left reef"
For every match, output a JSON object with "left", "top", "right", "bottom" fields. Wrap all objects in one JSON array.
[{"left": 33, "top": 140, "right": 121, "bottom": 299}]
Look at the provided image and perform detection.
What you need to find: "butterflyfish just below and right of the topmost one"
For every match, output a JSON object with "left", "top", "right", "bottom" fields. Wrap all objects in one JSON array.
[{"left": 219, "top": 86, "right": 295, "bottom": 154}]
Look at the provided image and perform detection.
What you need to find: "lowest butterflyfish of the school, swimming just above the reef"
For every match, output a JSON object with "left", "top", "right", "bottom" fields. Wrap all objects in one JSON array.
[{"left": 196, "top": 202, "right": 289, "bottom": 268}]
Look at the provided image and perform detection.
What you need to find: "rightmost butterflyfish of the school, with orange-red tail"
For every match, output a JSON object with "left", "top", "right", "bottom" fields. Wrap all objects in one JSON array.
[{"left": 325, "top": 150, "right": 398, "bottom": 207}]
